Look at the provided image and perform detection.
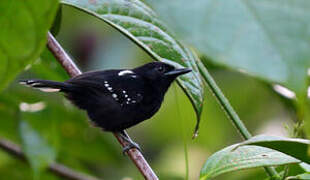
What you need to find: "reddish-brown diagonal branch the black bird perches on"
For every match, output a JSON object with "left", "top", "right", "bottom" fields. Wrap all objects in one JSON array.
[{"left": 47, "top": 33, "right": 158, "bottom": 180}]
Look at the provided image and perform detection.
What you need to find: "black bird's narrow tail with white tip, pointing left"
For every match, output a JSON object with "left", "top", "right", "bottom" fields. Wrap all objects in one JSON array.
[{"left": 19, "top": 79, "right": 72, "bottom": 92}]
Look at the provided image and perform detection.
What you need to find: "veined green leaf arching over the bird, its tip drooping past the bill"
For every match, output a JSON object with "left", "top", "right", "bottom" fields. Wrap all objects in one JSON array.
[{"left": 62, "top": 0, "right": 204, "bottom": 130}]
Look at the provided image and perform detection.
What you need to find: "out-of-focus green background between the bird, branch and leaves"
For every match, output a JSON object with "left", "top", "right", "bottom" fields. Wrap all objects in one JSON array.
[{"left": 0, "top": 6, "right": 295, "bottom": 180}]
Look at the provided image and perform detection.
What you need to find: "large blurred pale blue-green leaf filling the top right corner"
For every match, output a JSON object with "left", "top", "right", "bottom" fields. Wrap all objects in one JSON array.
[{"left": 147, "top": 0, "right": 310, "bottom": 95}]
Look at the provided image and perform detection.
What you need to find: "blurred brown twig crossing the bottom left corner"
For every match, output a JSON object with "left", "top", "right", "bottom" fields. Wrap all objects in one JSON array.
[{"left": 0, "top": 138, "right": 98, "bottom": 180}]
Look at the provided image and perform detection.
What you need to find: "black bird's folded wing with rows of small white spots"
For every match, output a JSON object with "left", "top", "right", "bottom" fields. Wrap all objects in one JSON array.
[{"left": 66, "top": 70, "right": 144, "bottom": 105}]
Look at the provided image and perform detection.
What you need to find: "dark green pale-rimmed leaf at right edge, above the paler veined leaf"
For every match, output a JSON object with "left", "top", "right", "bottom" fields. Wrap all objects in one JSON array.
[{"left": 240, "top": 135, "right": 310, "bottom": 163}]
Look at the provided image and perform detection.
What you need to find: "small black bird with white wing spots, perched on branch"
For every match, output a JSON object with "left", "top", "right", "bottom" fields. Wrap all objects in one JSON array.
[{"left": 20, "top": 62, "right": 191, "bottom": 151}]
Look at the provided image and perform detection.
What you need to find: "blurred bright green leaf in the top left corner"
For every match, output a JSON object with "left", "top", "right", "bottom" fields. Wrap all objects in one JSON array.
[{"left": 0, "top": 0, "right": 58, "bottom": 91}]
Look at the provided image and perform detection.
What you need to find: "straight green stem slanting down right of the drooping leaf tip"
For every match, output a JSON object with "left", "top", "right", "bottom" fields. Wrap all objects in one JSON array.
[{"left": 198, "top": 61, "right": 280, "bottom": 179}]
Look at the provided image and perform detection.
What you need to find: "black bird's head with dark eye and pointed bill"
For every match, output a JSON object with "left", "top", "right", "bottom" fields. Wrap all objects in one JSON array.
[{"left": 133, "top": 62, "right": 191, "bottom": 90}]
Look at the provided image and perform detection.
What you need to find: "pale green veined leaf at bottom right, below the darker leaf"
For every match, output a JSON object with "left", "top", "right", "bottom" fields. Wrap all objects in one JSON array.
[{"left": 200, "top": 144, "right": 300, "bottom": 179}]
